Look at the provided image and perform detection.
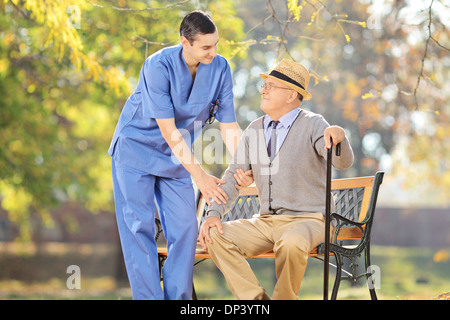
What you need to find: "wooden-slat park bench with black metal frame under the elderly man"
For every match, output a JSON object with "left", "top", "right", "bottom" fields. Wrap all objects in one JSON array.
[{"left": 156, "top": 172, "right": 384, "bottom": 300}]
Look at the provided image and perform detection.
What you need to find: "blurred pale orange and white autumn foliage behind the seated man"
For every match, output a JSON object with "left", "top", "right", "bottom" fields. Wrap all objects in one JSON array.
[{"left": 227, "top": 0, "right": 450, "bottom": 207}]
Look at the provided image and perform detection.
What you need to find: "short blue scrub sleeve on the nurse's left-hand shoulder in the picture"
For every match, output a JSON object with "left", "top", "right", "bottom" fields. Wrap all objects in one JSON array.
[{"left": 139, "top": 57, "right": 175, "bottom": 119}]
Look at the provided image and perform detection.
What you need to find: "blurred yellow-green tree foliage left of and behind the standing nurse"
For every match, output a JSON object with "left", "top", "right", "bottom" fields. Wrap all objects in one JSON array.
[{"left": 0, "top": 0, "right": 243, "bottom": 240}]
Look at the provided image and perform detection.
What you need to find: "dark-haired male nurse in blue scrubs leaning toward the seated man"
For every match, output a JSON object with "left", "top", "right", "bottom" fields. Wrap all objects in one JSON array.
[{"left": 108, "top": 11, "right": 252, "bottom": 300}]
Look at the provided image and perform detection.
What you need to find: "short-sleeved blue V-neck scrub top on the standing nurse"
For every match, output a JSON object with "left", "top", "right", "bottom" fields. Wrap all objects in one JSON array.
[{"left": 108, "top": 44, "right": 236, "bottom": 178}]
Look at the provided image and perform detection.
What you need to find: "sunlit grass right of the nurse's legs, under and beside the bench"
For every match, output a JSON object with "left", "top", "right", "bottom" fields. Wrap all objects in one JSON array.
[{"left": 194, "top": 246, "right": 450, "bottom": 300}]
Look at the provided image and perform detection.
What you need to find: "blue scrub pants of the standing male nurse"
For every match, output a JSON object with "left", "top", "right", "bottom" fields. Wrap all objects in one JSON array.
[{"left": 112, "top": 159, "right": 198, "bottom": 300}]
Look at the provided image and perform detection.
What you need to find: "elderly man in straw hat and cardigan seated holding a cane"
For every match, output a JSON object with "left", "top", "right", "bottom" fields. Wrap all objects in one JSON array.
[{"left": 199, "top": 59, "right": 353, "bottom": 299}]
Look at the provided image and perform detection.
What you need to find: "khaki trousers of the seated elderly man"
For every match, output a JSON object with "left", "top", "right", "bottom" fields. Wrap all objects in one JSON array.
[{"left": 207, "top": 212, "right": 325, "bottom": 300}]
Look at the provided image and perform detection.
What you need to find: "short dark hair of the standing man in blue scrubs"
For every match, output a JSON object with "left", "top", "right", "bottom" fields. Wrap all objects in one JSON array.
[{"left": 180, "top": 10, "right": 217, "bottom": 45}]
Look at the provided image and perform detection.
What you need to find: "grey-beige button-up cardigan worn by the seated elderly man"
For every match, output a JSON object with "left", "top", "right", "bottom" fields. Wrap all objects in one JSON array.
[{"left": 207, "top": 110, "right": 353, "bottom": 218}]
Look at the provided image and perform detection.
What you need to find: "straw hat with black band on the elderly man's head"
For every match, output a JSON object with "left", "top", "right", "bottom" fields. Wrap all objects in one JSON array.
[{"left": 259, "top": 59, "right": 312, "bottom": 100}]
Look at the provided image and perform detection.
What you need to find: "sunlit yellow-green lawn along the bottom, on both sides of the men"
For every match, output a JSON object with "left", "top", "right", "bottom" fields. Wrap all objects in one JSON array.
[{"left": 0, "top": 246, "right": 450, "bottom": 300}]
